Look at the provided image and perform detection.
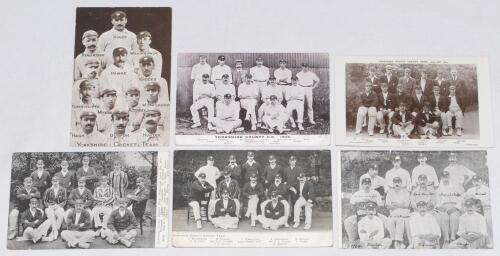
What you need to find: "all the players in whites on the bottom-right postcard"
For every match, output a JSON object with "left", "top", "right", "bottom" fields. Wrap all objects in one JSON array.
[{"left": 344, "top": 155, "right": 493, "bottom": 249}]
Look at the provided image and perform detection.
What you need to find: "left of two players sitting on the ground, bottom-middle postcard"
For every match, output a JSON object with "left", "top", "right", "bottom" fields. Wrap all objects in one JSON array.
[{"left": 212, "top": 189, "right": 239, "bottom": 229}]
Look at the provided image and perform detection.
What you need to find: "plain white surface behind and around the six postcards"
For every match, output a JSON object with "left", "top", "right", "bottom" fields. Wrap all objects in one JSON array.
[{"left": 0, "top": 0, "right": 500, "bottom": 256}]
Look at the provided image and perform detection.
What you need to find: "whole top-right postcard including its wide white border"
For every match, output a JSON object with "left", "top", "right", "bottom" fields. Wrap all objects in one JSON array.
[{"left": 336, "top": 57, "right": 492, "bottom": 146}]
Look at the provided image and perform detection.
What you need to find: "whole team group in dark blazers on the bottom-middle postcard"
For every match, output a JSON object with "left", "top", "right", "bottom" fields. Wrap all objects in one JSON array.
[{"left": 188, "top": 152, "right": 315, "bottom": 230}]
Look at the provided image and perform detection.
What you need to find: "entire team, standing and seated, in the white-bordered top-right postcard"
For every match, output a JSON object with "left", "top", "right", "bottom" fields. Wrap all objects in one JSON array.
[{"left": 355, "top": 65, "right": 468, "bottom": 139}]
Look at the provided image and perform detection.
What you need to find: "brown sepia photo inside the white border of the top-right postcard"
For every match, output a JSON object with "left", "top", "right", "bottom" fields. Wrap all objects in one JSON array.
[{"left": 345, "top": 63, "right": 479, "bottom": 139}]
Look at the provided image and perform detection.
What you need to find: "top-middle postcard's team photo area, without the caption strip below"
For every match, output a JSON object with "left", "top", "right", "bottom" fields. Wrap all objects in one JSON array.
[{"left": 176, "top": 53, "right": 330, "bottom": 135}]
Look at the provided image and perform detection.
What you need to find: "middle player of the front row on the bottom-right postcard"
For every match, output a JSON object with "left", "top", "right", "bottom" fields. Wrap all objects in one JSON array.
[{"left": 410, "top": 201, "right": 441, "bottom": 249}]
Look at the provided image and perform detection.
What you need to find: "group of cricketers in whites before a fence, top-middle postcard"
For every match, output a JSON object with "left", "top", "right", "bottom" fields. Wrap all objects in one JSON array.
[{"left": 190, "top": 55, "right": 320, "bottom": 133}]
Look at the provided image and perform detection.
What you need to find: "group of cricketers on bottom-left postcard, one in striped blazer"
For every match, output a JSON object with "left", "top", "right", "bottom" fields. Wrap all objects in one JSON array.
[{"left": 8, "top": 156, "right": 149, "bottom": 248}]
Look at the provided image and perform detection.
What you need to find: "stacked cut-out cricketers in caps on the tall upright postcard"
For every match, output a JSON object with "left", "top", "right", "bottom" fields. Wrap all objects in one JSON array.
[{"left": 72, "top": 11, "right": 169, "bottom": 146}]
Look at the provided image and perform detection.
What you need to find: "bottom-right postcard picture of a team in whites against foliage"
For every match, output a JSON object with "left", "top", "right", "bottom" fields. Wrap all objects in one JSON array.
[{"left": 340, "top": 150, "right": 493, "bottom": 249}]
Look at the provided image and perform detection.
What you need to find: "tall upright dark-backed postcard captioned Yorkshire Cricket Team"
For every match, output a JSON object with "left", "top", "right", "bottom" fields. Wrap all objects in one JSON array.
[{"left": 70, "top": 7, "right": 172, "bottom": 147}]
